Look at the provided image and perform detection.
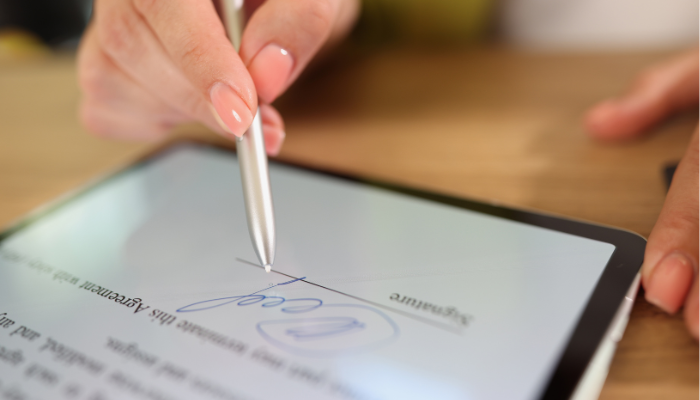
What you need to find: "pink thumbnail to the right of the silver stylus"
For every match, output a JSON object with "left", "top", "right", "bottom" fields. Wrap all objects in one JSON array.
[{"left": 248, "top": 44, "right": 294, "bottom": 103}]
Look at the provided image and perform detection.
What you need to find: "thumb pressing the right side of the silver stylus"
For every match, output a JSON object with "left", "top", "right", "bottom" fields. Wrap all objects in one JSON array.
[{"left": 240, "top": 0, "right": 357, "bottom": 103}]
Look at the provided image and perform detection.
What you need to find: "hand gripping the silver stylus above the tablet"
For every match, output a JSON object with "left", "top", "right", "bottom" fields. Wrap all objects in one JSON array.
[{"left": 78, "top": 0, "right": 358, "bottom": 155}]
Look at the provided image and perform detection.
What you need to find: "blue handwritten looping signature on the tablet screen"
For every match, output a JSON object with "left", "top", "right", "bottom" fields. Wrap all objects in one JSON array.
[{"left": 177, "top": 277, "right": 399, "bottom": 357}]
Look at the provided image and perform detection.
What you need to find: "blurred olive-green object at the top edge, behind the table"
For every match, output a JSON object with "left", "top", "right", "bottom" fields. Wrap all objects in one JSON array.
[{"left": 353, "top": 0, "right": 495, "bottom": 44}]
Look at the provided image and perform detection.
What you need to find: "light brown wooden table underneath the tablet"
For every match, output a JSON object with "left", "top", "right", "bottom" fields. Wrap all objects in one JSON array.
[{"left": 0, "top": 49, "right": 698, "bottom": 400}]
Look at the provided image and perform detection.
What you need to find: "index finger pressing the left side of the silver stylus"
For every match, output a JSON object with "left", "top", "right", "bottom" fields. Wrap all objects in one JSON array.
[{"left": 132, "top": 0, "right": 257, "bottom": 136}]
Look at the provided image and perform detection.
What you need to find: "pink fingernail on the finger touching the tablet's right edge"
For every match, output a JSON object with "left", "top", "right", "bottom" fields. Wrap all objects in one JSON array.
[{"left": 645, "top": 252, "right": 695, "bottom": 314}]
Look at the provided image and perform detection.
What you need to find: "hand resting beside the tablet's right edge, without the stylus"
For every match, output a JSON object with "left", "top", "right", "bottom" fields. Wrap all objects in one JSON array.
[{"left": 586, "top": 51, "right": 698, "bottom": 340}]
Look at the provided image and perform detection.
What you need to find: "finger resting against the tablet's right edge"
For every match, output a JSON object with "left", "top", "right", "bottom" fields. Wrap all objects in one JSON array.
[{"left": 642, "top": 129, "right": 698, "bottom": 322}]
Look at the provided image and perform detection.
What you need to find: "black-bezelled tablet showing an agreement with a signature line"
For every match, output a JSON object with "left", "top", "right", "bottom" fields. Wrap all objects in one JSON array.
[{"left": 0, "top": 143, "right": 645, "bottom": 400}]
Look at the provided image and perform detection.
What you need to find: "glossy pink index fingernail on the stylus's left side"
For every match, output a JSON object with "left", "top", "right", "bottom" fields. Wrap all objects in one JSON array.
[{"left": 209, "top": 83, "right": 253, "bottom": 137}]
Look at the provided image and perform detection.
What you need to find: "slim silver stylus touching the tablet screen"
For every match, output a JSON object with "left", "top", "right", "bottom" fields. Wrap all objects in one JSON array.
[{"left": 214, "top": 0, "right": 275, "bottom": 272}]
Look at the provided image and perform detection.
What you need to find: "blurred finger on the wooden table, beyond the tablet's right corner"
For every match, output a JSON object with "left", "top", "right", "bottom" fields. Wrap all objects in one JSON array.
[{"left": 585, "top": 50, "right": 698, "bottom": 140}]
